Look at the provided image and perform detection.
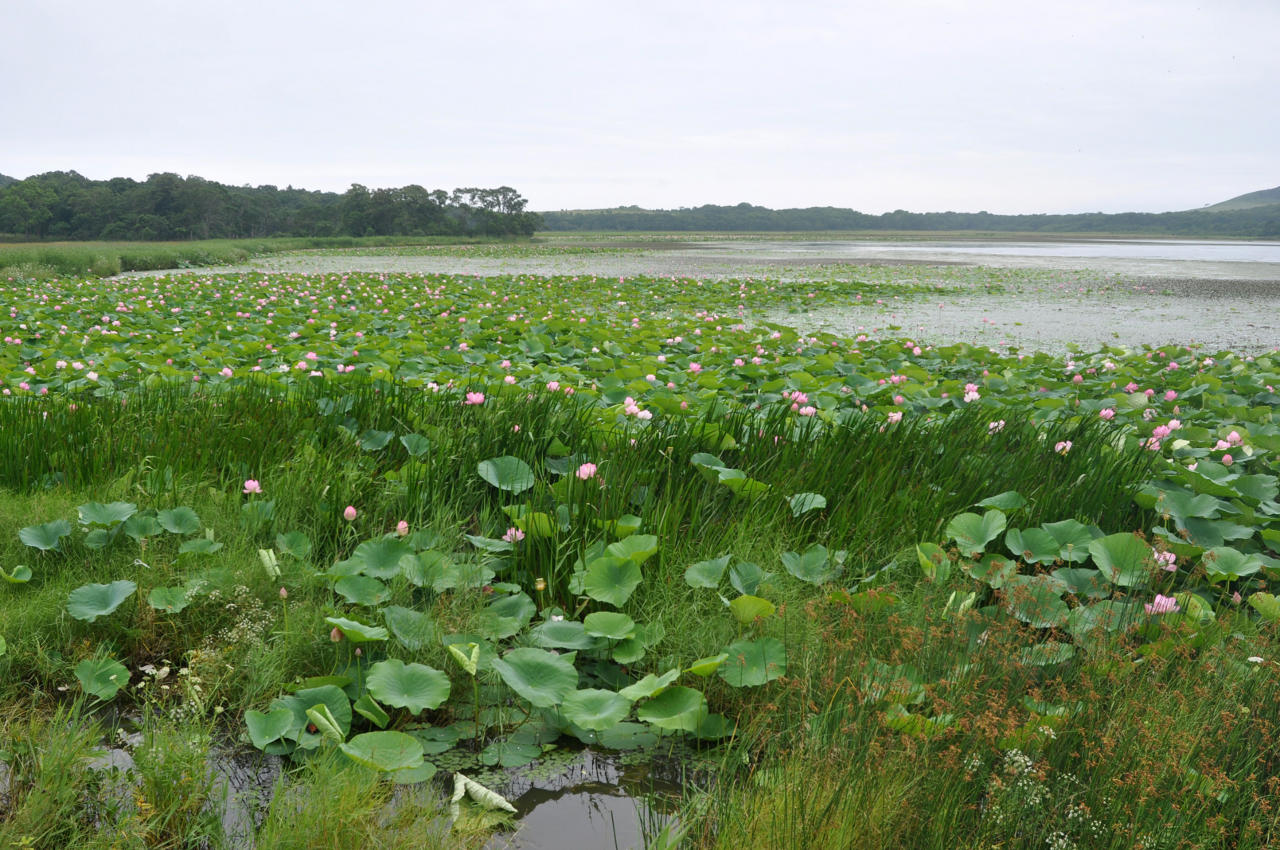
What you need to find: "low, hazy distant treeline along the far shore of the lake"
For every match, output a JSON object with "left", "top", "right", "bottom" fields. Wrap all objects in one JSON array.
[{"left": 541, "top": 204, "right": 1280, "bottom": 238}]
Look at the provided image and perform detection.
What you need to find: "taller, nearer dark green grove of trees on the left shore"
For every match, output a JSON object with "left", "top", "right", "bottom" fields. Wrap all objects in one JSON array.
[{"left": 0, "top": 172, "right": 541, "bottom": 241}]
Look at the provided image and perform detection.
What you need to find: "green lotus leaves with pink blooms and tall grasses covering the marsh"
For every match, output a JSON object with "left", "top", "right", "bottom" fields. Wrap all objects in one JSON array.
[{"left": 0, "top": 256, "right": 1280, "bottom": 846}]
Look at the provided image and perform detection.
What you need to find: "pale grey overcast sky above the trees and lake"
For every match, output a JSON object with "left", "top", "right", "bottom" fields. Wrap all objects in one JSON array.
[{"left": 0, "top": 0, "right": 1280, "bottom": 213}]
